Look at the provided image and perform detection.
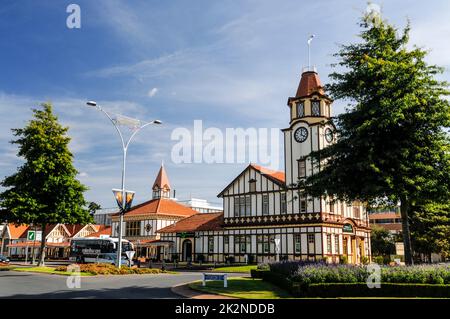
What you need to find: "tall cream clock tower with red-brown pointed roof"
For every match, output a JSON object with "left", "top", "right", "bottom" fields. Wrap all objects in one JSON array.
[{"left": 283, "top": 67, "right": 334, "bottom": 202}]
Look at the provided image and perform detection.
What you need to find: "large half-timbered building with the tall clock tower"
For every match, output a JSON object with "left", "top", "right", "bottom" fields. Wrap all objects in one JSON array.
[{"left": 160, "top": 69, "right": 371, "bottom": 264}]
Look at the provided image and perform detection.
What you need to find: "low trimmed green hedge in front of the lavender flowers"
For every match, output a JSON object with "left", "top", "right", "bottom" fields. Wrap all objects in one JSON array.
[{"left": 290, "top": 283, "right": 450, "bottom": 298}]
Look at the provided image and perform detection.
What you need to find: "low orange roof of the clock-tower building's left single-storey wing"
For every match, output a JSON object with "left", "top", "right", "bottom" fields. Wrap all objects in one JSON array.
[{"left": 157, "top": 212, "right": 223, "bottom": 233}]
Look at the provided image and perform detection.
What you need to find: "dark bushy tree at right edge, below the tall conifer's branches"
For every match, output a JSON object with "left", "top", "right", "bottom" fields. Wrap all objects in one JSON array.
[{"left": 411, "top": 202, "right": 450, "bottom": 261}]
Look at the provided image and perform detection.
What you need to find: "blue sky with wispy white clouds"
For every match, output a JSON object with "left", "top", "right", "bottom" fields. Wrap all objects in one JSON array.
[{"left": 0, "top": 0, "right": 450, "bottom": 208}]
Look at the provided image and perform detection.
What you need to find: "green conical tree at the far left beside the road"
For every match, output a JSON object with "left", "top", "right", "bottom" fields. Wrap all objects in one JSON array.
[{"left": 0, "top": 103, "right": 92, "bottom": 265}]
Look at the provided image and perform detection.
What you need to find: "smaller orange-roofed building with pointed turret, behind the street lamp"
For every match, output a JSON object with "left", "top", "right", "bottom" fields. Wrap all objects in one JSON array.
[{"left": 112, "top": 165, "right": 198, "bottom": 260}]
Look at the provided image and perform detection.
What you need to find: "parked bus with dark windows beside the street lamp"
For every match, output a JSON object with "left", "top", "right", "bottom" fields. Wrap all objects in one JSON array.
[{"left": 69, "top": 237, "right": 134, "bottom": 264}]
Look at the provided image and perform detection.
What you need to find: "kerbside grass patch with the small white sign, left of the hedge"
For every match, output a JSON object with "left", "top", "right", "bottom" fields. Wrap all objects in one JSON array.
[{"left": 189, "top": 277, "right": 292, "bottom": 299}]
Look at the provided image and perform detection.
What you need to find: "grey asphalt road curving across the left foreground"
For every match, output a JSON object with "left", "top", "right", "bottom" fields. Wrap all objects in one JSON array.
[{"left": 0, "top": 271, "right": 209, "bottom": 299}]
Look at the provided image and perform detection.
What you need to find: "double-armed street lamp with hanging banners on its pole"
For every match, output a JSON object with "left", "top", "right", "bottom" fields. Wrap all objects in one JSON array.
[{"left": 86, "top": 101, "right": 162, "bottom": 268}]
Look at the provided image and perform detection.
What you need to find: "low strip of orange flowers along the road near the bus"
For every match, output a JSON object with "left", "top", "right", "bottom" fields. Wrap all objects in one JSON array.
[{"left": 55, "top": 264, "right": 166, "bottom": 275}]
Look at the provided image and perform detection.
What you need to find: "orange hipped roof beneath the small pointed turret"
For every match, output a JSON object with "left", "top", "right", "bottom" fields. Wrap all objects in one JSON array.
[{"left": 113, "top": 198, "right": 197, "bottom": 217}]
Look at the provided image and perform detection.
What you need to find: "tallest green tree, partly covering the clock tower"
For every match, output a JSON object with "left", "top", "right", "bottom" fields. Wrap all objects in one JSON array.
[{"left": 298, "top": 16, "right": 450, "bottom": 264}]
